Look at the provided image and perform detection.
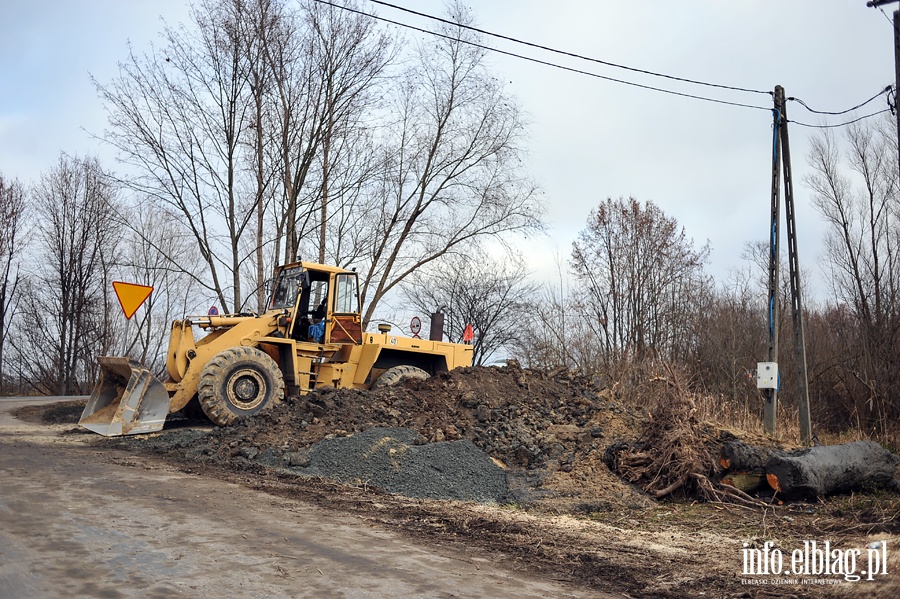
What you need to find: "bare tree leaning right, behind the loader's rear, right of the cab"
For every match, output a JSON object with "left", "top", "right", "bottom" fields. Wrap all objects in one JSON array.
[{"left": 362, "top": 3, "right": 541, "bottom": 323}]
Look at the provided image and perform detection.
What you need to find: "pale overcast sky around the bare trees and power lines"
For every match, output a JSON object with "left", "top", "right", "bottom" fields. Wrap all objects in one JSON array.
[{"left": 0, "top": 0, "right": 897, "bottom": 295}]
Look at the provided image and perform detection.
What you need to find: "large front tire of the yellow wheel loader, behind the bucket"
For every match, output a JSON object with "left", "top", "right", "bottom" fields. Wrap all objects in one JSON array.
[{"left": 197, "top": 347, "right": 284, "bottom": 426}]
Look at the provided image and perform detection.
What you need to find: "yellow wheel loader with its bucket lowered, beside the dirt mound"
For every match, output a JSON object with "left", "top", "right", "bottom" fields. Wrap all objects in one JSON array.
[{"left": 79, "top": 262, "right": 473, "bottom": 436}]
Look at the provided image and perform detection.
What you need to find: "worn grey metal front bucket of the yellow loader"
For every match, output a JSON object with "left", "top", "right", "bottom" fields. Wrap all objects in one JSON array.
[{"left": 78, "top": 356, "right": 169, "bottom": 437}]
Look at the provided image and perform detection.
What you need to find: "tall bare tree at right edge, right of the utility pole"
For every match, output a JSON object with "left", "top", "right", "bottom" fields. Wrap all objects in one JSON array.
[{"left": 805, "top": 120, "right": 900, "bottom": 430}]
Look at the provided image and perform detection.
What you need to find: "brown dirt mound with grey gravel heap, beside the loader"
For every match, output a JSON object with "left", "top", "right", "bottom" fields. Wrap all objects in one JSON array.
[{"left": 110, "top": 365, "right": 649, "bottom": 513}]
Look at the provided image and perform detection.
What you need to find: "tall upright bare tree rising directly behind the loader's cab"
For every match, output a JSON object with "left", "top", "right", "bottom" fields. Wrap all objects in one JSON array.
[{"left": 248, "top": 0, "right": 394, "bottom": 262}]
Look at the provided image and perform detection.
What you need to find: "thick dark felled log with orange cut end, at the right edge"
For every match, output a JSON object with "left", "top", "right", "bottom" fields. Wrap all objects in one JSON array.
[{"left": 765, "top": 441, "right": 900, "bottom": 499}]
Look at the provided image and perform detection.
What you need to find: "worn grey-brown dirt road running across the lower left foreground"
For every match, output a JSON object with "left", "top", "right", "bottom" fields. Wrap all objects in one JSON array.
[{"left": 0, "top": 399, "right": 612, "bottom": 599}]
